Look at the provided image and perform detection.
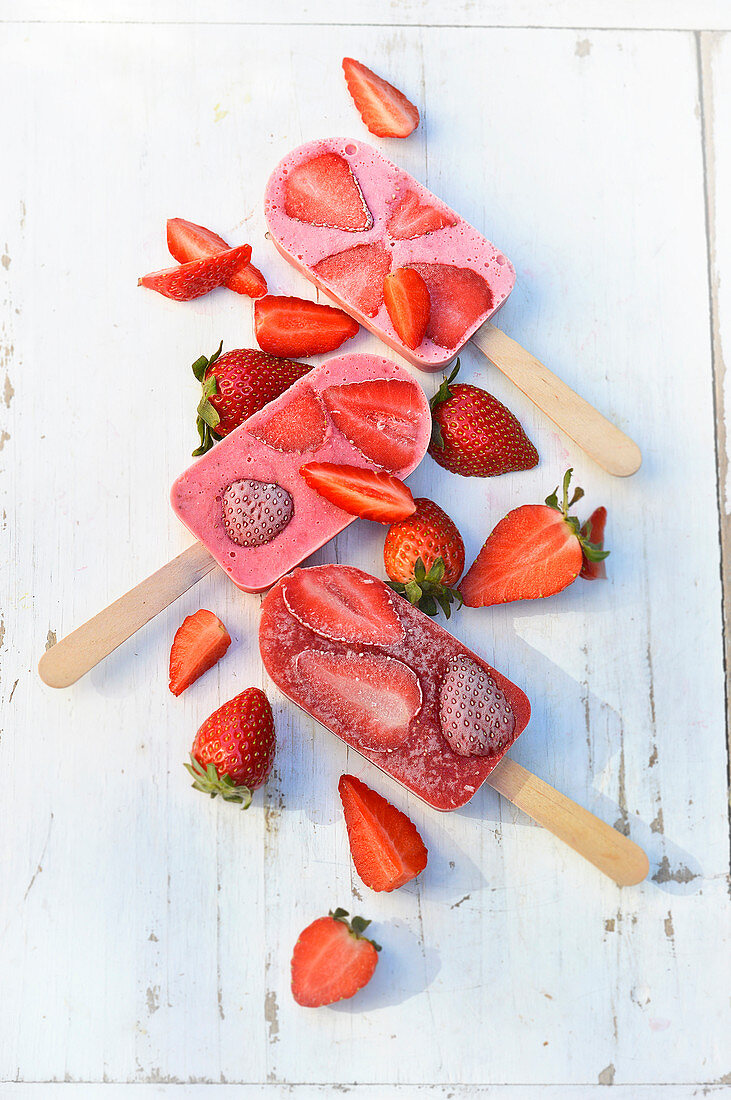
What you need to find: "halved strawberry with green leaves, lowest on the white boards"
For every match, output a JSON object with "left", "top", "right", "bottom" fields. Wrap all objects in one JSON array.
[{"left": 291, "top": 909, "right": 380, "bottom": 1009}]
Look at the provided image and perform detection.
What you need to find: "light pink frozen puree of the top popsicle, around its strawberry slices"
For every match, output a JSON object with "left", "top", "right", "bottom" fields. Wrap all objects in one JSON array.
[{"left": 265, "top": 138, "right": 516, "bottom": 371}]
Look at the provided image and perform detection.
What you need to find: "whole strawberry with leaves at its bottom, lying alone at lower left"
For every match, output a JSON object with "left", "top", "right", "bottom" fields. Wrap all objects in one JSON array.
[{"left": 185, "top": 688, "right": 276, "bottom": 810}]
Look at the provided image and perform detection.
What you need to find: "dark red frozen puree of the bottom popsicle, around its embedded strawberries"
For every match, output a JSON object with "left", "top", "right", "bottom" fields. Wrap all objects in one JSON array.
[{"left": 259, "top": 565, "right": 531, "bottom": 811}]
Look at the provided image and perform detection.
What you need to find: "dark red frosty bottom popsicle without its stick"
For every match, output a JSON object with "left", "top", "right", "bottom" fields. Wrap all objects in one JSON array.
[{"left": 259, "top": 565, "right": 531, "bottom": 810}]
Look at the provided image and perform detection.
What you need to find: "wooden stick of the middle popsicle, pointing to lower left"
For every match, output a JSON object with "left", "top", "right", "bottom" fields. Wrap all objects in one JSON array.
[{"left": 38, "top": 542, "right": 215, "bottom": 688}]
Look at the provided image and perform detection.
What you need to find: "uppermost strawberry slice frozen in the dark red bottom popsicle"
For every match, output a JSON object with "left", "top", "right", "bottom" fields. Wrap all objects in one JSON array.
[{"left": 281, "top": 565, "right": 403, "bottom": 646}]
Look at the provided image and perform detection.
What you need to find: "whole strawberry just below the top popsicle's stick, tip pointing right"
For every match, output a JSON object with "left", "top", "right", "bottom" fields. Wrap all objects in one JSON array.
[{"left": 429, "top": 360, "right": 539, "bottom": 477}]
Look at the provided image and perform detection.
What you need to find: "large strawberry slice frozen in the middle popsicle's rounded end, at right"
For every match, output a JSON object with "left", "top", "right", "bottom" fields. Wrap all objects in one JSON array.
[{"left": 322, "top": 378, "right": 421, "bottom": 470}]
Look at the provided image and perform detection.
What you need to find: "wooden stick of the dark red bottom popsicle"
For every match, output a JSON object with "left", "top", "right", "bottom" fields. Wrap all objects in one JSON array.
[{"left": 487, "top": 757, "right": 650, "bottom": 887}]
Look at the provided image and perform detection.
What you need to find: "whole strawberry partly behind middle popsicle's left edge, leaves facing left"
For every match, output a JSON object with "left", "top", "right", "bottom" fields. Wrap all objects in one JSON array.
[{"left": 192, "top": 342, "right": 312, "bottom": 455}]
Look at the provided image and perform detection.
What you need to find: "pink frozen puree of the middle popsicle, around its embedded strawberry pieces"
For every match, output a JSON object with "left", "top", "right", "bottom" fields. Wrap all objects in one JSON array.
[{"left": 170, "top": 355, "right": 431, "bottom": 592}]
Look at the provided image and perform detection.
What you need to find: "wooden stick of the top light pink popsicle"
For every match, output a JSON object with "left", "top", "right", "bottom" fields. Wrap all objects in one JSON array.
[{"left": 472, "top": 321, "right": 642, "bottom": 477}]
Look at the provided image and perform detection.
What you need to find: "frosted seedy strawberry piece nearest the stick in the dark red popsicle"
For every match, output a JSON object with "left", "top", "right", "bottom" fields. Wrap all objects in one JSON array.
[{"left": 439, "top": 657, "right": 516, "bottom": 756}]
